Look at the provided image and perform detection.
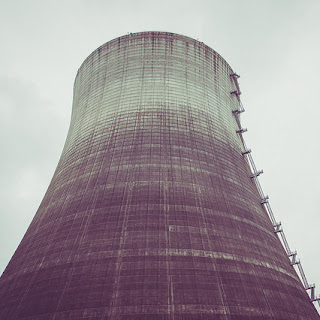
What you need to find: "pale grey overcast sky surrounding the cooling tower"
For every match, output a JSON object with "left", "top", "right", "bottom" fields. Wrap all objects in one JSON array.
[{"left": 0, "top": 0, "right": 320, "bottom": 312}]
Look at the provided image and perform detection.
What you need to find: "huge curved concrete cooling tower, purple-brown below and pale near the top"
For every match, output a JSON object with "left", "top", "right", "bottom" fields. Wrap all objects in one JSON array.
[{"left": 0, "top": 32, "right": 319, "bottom": 320}]
